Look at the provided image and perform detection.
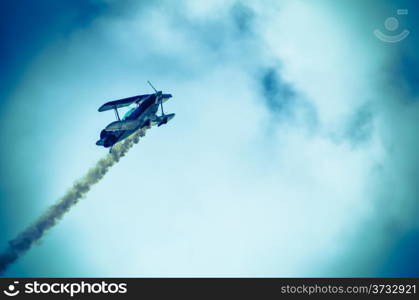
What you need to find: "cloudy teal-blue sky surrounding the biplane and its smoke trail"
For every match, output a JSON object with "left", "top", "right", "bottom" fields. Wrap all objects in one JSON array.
[{"left": 0, "top": 0, "right": 419, "bottom": 277}]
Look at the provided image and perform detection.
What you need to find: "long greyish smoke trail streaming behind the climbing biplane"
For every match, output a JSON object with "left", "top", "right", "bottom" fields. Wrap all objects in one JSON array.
[{"left": 0, "top": 129, "right": 146, "bottom": 274}]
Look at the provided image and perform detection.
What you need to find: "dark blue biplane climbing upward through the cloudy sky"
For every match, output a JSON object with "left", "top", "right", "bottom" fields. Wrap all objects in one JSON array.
[{"left": 96, "top": 81, "right": 175, "bottom": 152}]
